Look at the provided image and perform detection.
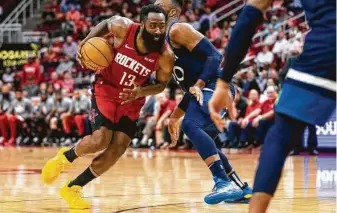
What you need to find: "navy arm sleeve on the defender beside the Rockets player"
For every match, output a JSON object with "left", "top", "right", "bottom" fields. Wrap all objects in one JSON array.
[{"left": 192, "top": 37, "right": 222, "bottom": 83}]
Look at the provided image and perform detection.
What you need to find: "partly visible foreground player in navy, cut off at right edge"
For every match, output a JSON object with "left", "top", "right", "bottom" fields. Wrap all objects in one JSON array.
[{"left": 209, "top": 0, "right": 336, "bottom": 213}]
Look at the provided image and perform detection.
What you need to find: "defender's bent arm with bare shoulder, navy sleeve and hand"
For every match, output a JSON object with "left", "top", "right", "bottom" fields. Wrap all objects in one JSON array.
[{"left": 169, "top": 23, "right": 222, "bottom": 103}]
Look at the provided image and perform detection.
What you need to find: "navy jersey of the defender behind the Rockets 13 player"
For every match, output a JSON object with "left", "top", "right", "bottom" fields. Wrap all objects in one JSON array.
[{"left": 166, "top": 21, "right": 221, "bottom": 92}]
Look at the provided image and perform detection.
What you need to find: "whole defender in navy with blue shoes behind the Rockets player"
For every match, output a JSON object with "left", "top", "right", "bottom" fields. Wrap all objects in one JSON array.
[{"left": 155, "top": 0, "right": 251, "bottom": 204}]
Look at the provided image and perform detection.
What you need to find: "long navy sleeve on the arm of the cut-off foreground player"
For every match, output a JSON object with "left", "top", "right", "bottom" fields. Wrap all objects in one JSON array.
[{"left": 221, "top": 5, "right": 263, "bottom": 83}]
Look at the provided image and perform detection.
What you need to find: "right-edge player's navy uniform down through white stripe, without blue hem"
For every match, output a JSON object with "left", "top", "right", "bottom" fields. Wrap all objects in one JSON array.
[{"left": 286, "top": 0, "right": 336, "bottom": 97}]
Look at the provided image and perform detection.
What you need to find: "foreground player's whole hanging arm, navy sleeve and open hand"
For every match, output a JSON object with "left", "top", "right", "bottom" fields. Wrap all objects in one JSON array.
[{"left": 208, "top": 0, "right": 272, "bottom": 130}]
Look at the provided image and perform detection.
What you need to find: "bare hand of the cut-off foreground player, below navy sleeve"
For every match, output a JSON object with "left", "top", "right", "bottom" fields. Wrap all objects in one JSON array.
[{"left": 208, "top": 80, "right": 236, "bottom": 132}]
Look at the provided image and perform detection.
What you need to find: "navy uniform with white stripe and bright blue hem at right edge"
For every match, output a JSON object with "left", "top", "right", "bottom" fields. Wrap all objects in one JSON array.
[{"left": 275, "top": 0, "right": 336, "bottom": 125}]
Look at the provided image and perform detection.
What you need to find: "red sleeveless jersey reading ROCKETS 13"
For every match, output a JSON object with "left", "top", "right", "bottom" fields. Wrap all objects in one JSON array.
[{"left": 95, "top": 23, "right": 166, "bottom": 103}]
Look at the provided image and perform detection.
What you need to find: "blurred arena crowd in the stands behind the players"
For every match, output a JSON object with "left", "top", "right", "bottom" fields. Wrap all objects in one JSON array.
[{"left": 0, "top": 0, "right": 337, "bottom": 151}]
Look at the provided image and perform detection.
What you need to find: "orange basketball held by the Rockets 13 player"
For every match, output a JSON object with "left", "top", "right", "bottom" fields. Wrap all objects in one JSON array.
[{"left": 81, "top": 37, "right": 114, "bottom": 71}]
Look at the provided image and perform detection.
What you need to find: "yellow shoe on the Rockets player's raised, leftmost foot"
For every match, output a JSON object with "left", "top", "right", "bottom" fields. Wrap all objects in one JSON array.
[{"left": 41, "top": 147, "right": 71, "bottom": 184}]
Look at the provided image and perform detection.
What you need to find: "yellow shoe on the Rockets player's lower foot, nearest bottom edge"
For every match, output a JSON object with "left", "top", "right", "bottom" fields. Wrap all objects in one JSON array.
[{"left": 59, "top": 181, "right": 90, "bottom": 209}]
